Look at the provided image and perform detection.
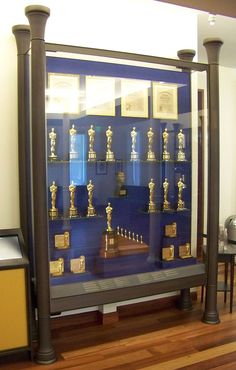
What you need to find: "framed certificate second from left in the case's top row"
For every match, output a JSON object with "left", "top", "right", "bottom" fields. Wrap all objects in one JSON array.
[{"left": 85, "top": 76, "right": 116, "bottom": 116}]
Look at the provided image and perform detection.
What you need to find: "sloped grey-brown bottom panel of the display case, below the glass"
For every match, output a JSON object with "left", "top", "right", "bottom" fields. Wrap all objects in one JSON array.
[{"left": 51, "top": 263, "right": 206, "bottom": 314}]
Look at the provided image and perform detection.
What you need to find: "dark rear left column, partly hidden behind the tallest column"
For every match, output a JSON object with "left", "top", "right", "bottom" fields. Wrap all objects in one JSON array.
[{"left": 12, "top": 25, "right": 32, "bottom": 252}]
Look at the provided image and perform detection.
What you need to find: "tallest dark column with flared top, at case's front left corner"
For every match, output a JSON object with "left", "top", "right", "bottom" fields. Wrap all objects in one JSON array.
[{"left": 25, "top": 5, "right": 56, "bottom": 364}]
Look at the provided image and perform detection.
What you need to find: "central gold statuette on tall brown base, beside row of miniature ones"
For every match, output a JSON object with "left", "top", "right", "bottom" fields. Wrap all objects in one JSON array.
[{"left": 100, "top": 203, "right": 119, "bottom": 258}]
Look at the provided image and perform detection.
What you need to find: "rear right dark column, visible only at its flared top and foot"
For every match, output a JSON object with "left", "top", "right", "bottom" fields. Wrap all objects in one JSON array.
[{"left": 177, "top": 49, "right": 196, "bottom": 310}]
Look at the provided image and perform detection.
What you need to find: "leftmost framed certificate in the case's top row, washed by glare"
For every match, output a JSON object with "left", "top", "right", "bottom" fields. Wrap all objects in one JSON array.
[{"left": 47, "top": 73, "right": 80, "bottom": 114}]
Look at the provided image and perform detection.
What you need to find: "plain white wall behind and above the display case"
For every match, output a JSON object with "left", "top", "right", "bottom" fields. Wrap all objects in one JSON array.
[{"left": 0, "top": 0, "right": 197, "bottom": 228}]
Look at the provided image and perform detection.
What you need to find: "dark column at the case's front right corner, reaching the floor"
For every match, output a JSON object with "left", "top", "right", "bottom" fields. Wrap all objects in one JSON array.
[{"left": 202, "top": 39, "right": 223, "bottom": 324}]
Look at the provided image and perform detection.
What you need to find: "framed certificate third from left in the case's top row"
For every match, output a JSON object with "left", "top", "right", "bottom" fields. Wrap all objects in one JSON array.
[{"left": 121, "top": 79, "right": 148, "bottom": 118}]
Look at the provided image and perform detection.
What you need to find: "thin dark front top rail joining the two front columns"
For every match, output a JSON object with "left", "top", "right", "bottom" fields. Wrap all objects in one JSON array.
[{"left": 45, "top": 43, "right": 208, "bottom": 72}]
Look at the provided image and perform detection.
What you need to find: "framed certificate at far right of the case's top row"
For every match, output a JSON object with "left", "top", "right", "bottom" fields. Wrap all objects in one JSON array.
[{"left": 152, "top": 82, "right": 178, "bottom": 119}]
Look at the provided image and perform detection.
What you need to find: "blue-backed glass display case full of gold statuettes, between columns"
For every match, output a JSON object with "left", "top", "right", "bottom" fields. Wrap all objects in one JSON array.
[{"left": 42, "top": 45, "right": 205, "bottom": 312}]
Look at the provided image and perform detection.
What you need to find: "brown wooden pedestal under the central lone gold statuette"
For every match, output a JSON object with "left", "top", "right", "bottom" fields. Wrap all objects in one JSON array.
[{"left": 100, "top": 230, "right": 119, "bottom": 258}]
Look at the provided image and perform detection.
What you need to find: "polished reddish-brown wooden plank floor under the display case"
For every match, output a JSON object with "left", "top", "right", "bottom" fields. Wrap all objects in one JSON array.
[{"left": 0, "top": 284, "right": 236, "bottom": 370}]
